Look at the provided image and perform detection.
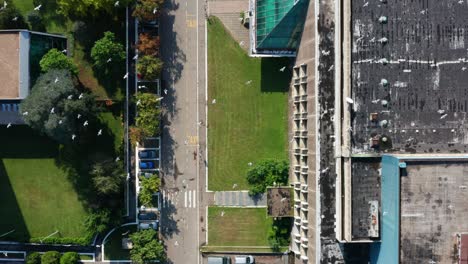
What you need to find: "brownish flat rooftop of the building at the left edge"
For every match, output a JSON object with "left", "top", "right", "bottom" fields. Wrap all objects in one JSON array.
[{"left": 0, "top": 32, "right": 20, "bottom": 99}]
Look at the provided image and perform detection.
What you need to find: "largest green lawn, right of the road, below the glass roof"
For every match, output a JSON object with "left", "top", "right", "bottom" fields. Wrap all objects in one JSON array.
[{"left": 208, "top": 17, "right": 291, "bottom": 191}]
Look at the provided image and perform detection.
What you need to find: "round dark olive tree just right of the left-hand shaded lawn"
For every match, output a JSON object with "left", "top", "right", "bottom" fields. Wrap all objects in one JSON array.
[{"left": 90, "top": 160, "right": 125, "bottom": 195}]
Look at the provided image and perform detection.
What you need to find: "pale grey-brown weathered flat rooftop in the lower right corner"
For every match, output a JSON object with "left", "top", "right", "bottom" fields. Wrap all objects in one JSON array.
[{"left": 400, "top": 161, "right": 468, "bottom": 263}]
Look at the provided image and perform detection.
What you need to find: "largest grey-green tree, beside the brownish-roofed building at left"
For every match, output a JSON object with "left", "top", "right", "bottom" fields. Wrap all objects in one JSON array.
[{"left": 20, "top": 69, "right": 98, "bottom": 143}]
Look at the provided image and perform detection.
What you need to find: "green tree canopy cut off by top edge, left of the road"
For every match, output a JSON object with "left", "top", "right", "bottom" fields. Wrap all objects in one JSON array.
[{"left": 57, "top": 0, "right": 133, "bottom": 17}]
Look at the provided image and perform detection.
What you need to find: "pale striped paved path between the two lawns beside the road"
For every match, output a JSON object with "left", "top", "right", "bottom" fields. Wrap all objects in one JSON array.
[{"left": 215, "top": 191, "right": 266, "bottom": 207}]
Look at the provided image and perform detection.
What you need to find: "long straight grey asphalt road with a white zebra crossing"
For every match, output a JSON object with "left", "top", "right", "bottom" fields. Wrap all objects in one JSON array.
[{"left": 160, "top": 0, "right": 206, "bottom": 264}]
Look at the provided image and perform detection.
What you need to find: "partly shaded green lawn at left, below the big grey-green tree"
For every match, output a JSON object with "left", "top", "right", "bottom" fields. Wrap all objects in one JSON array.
[{"left": 0, "top": 126, "right": 86, "bottom": 241}]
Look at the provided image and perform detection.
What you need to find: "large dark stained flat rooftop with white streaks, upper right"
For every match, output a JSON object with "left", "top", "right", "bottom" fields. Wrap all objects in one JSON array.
[{"left": 351, "top": 0, "right": 468, "bottom": 153}]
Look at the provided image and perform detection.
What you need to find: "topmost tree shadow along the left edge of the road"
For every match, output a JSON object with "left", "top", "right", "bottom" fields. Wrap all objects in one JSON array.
[{"left": 160, "top": 0, "right": 186, "bottom": 82}]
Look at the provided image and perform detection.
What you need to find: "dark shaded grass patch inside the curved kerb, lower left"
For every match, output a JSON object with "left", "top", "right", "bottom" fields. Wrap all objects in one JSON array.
[{"left": 104, "top": 225, "right": 137, "bottom": 260}]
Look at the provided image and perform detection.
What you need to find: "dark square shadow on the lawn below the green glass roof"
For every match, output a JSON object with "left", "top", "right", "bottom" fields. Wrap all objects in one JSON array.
[{"left": 260, "top": 58, "right": 294, "bottom": 93}]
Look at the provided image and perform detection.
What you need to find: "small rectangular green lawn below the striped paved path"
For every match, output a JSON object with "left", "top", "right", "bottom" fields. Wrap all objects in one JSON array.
[{"left": 208, "top": 207, "right": 273, "bottom": 246}]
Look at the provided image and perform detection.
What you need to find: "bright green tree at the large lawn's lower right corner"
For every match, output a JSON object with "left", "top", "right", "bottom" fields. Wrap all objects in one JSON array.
[{"left": 247, "top": 159, "right": 289, "bottom": 195}]
